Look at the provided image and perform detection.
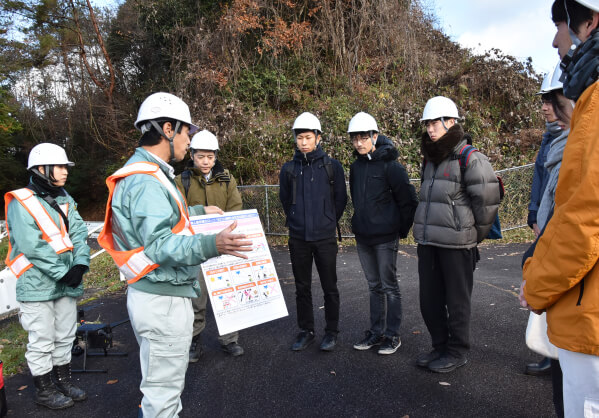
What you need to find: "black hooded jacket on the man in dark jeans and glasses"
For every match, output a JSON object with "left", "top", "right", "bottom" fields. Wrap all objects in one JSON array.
[{"left": 349, "top": 135, "right": 418, "bottom": 245}]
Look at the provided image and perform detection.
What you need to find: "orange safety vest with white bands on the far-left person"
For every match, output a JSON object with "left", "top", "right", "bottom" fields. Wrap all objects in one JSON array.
[{"left": 4, "top": 188, "right": 73, "bottom": 277}]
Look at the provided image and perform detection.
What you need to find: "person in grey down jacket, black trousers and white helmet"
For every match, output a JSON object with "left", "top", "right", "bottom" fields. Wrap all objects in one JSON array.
[{"left": 413, "top": 96, "right": 500, "bottom": 372}]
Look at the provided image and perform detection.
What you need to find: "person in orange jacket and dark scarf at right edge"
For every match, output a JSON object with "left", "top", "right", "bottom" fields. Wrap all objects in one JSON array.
[{"left": 520, "top": 0, "right": 599, "bottom": 417}]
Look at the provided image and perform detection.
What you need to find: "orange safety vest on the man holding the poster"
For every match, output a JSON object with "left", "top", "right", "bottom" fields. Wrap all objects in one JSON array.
[{"left": 98, "top": 162, "right": 193, "bottom": 284}]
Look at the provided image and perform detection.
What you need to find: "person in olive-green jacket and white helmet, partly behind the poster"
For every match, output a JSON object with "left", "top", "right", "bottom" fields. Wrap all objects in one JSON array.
[{"left": 175, "top": 130, "right": 243, "bottom": 363}]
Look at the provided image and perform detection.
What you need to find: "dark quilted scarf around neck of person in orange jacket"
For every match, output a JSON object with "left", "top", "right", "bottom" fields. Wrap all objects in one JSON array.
[{"left": 564, "top": 30, "right": 599, "bottom": 101}]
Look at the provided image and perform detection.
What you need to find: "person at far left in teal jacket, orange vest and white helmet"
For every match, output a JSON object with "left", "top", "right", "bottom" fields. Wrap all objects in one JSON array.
[{"left": 4, "top": 143, "right": 89, "bottom": 409}]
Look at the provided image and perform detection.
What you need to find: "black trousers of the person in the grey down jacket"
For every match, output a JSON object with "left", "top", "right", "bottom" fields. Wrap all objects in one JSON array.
[{"left": 418, "top": 245, "right": 475, "bottom": 357}]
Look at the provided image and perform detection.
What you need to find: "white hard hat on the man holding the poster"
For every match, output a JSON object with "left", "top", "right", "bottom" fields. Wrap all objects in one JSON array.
[{"left": 134, "top": 93, "right": 199, "bottom": 135}]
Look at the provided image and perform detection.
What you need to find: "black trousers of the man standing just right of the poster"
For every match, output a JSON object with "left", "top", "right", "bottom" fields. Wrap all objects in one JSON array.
[{"left": 289, "top": 237, "right": 339, "bottom": 334}]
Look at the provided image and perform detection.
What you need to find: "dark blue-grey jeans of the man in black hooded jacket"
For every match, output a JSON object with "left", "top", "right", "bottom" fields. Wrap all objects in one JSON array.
[{"left": 357, "top": 239, "right": 402, "bottom": 337}]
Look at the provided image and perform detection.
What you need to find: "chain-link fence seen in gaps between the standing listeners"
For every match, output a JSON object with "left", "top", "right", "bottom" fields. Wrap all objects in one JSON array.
[{"left": 239, "top": 164, "right": 534, "bottom": 237}]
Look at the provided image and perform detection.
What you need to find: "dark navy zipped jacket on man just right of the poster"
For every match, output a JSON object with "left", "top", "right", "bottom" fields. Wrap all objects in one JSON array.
[{"left": 279, "top": 145, "right": 347, "bottom": 241}]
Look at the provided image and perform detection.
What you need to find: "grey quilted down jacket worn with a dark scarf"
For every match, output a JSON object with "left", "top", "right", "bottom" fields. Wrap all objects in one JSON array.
[{"left": 413, "top": 125, "right": 500, "bottom": 249}]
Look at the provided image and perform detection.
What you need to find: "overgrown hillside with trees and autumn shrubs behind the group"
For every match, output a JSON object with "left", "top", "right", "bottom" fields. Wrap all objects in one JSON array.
[{"left": 0, "top": 0, "right": 544, "bottom": 219}]
